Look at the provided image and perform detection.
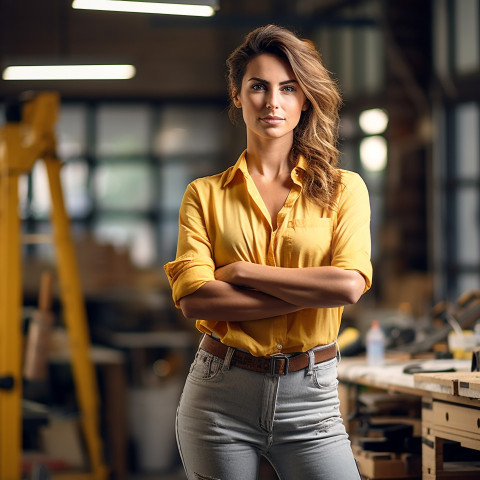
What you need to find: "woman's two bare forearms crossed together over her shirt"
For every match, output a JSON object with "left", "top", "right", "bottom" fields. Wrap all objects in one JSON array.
[{"left": 180, "top": 262, "right": 365, "bottom": 322}]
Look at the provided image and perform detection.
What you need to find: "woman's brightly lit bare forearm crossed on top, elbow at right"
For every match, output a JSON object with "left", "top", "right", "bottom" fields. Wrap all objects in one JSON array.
[{"left": 215, "top": 262, "right": 365, "bottom": 308}]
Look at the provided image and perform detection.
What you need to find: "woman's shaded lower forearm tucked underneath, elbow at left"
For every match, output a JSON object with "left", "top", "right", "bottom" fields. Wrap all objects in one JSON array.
[{"left": 180, "top": 280, "right": 302, "bottom": 322}]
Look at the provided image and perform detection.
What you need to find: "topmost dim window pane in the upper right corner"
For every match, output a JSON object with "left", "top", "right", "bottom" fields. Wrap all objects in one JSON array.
[{"left": 455, "top": 0, "right": 480, "bottom": 73}]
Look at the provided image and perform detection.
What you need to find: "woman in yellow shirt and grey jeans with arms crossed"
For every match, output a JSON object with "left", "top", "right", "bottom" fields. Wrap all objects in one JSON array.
[{"left": 165, "top": 25, "right": 372, "bottom": 480}]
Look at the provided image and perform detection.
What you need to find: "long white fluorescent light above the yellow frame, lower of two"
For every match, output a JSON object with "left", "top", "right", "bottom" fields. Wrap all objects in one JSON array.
[{"left": 2, "top": 65, "right": 135, "bottom": 80}]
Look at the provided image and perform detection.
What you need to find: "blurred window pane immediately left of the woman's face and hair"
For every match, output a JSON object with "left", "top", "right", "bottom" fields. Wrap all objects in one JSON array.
[{"left": 154, "top": 106, "right": 224, "bottom": 155}]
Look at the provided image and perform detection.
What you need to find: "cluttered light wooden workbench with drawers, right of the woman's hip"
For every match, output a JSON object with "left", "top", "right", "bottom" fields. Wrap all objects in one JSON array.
[{"left": 338, "top": 358, "right": 480, "bottom": 480}]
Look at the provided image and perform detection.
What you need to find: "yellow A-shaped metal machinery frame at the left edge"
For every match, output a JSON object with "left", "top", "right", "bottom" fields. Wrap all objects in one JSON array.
[{"left": 0, "top": 92, "right": 108, "bottom": 480}]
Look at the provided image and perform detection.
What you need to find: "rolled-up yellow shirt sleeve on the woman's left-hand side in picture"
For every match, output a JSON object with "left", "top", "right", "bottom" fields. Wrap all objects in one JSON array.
[{"left": 163, "top": 184, "right": 215, "bottom": 308}]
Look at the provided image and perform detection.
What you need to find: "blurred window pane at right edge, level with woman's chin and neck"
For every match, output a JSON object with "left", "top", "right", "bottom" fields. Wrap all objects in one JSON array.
[{"left": 455, "top": 102, "right": 480, "bottom": 179}]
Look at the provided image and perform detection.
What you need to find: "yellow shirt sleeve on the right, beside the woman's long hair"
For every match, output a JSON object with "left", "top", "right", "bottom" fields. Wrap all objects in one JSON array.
[{"left": 332, "top": 172, "right": 372, "bottom": 291}]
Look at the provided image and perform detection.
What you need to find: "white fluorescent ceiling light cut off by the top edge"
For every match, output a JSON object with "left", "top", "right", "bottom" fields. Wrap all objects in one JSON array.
[{"left": 72, "top": 0, "right": 215, "bottom": 17}]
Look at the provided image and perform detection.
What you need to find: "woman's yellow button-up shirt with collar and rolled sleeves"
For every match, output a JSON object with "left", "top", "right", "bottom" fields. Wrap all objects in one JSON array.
[{"left": 164, "top": 152, "right": 372, "bottom": 356}]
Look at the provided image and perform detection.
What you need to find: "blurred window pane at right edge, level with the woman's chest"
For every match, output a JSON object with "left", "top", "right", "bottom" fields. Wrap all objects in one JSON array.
[{"left": 455, "top": 188, "right": 480, "bottom": 266}]
